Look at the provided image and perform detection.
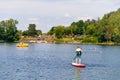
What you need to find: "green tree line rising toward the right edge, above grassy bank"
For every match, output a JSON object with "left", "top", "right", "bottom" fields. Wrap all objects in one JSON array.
[{"left": 48, "top": 9, "right": 120, "bottom": 43}]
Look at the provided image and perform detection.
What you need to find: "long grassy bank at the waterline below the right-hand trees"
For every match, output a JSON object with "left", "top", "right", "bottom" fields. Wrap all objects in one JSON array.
[{"left": 54, "top": 37, "right": 120, "bottom": 45}]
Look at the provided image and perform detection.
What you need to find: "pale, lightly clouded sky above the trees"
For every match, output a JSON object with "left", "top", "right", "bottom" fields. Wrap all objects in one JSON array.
[{"left": 0, "top": 0, "right": 120, "bottom": 33}]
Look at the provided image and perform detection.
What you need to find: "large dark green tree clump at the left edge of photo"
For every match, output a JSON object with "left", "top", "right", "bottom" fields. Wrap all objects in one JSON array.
[{"left": 0, "top": 19, "right": 19, "bottom": 42}]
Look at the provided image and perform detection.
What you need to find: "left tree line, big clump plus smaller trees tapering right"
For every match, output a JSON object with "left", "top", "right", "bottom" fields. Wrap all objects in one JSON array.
[{"left": 0, "top": 19, "right": 42, "bottom": 42}]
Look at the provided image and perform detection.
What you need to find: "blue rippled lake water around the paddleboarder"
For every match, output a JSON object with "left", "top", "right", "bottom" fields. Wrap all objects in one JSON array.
[{"left": 0, "top": 43, "right": 120, "bottom": 80}]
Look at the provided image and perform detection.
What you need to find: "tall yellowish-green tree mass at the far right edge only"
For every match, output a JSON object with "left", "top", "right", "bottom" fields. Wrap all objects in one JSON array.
[{"left": 97, "top": 10, "right": 120, "bottom": 43}]
